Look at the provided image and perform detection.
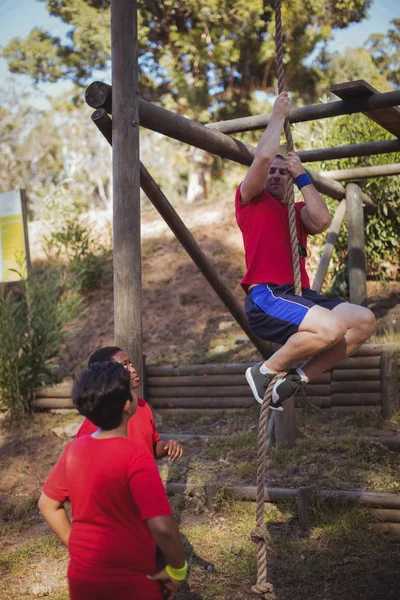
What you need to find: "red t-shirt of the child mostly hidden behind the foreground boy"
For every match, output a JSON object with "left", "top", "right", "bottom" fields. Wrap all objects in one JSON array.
[{"left": 76, "top": 398, "right": 161, "bottom": 456}]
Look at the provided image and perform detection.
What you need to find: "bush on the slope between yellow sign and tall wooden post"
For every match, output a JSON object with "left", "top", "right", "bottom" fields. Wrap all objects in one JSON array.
[{"left": 46, "top": 211, "right": 112, "bottom": 293}]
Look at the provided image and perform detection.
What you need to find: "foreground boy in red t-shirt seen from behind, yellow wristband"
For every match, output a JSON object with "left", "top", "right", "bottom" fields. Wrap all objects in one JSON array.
[{"left": 39, "top": 362, "right": 187, "bottom": 600}]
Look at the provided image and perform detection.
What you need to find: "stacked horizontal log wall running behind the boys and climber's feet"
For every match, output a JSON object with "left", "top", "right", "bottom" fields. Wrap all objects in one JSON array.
[{"left": 34, "top": 344, "right": 400, "bottom": 418}]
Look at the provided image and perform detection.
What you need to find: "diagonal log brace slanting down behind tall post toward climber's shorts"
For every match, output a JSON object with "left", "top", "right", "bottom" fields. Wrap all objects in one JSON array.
[{"left": 92, "top": 108, "right": 274, "bottom": 358}]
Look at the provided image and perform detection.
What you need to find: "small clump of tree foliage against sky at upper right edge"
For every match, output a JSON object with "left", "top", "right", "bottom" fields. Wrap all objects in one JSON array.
[{"left": 365, "top": 19, "right": 400, "bottom": 86}]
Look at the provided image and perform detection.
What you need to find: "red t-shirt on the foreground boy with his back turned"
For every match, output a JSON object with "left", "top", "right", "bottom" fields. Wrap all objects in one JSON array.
[{"left": 43, "top": 435, "right": 171, "bottom": 600}]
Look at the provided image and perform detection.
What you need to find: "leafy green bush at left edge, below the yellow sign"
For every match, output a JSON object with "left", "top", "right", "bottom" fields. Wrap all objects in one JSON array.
[{"left": 0, "top": 268, "right": 83, "bottom": 421}]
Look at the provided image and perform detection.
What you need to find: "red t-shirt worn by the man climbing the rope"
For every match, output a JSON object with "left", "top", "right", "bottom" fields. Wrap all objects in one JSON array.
[{"left": 235, "top": 186, "right": 310, "bottom": 291}]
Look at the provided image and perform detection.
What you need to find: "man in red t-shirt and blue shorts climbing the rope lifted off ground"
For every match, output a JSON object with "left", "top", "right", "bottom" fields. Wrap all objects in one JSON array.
[{"left": 235, "top": 92, "right": 375, "bottom": 410}]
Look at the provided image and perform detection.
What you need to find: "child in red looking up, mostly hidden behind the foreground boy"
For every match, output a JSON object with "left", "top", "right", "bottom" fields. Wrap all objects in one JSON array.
[{"left": 76, "top": 346, "right": 183, "bottom": 461}]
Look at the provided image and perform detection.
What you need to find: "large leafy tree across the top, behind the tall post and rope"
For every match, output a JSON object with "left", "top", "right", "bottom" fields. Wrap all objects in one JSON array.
[{"left": 2, "top": 0, "right": 372, "bottom": 120}]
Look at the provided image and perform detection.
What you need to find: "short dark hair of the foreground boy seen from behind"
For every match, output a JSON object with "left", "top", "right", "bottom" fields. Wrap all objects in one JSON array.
[{"left": 72, "top": 361, "right": 132, "bottom": 431}]
